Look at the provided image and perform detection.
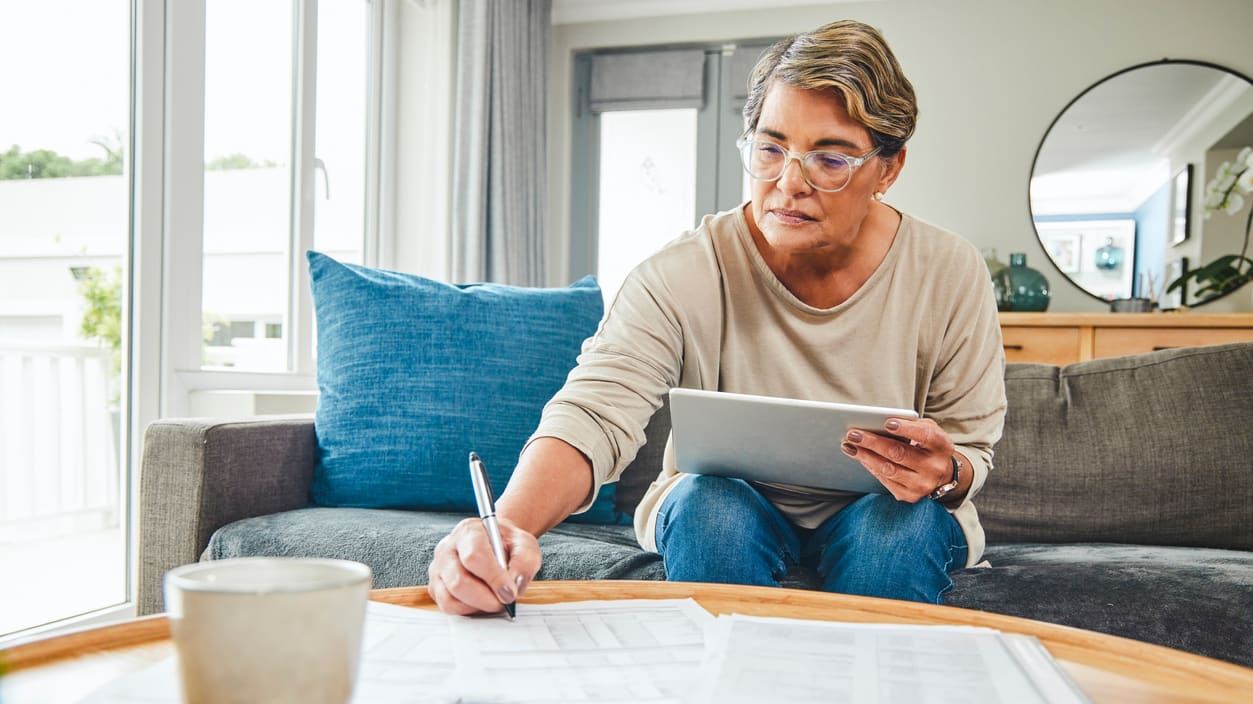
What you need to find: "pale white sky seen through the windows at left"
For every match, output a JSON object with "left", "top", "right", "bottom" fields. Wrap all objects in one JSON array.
[{"left": 0, "top": 0, "right": 365, "bottom": 163}]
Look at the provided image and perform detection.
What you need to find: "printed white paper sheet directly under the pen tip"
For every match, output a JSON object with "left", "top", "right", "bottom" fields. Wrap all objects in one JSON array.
[{"left": 452, "top": 599, "right": 713, "bottom": 703}]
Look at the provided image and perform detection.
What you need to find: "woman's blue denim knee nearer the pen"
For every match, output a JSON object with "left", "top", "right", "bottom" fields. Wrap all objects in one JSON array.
[{"left": 655, "top": 475, "right": 799, "bottom": 585}]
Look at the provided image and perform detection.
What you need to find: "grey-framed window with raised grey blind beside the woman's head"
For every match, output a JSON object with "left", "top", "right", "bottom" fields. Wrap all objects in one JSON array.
[{"left": 570, "top": 40, "right": 768, "bottom": 295}]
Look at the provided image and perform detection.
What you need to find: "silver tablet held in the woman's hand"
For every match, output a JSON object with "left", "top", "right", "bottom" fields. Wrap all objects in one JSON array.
[{"left": 670, "top": 388, "right": 918, "bottom": 494}]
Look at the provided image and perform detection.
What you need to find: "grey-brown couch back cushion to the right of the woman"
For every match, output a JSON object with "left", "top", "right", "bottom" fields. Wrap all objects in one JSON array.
[{"left": 975, "top": 343, "right": 1253, "bottom": 550}]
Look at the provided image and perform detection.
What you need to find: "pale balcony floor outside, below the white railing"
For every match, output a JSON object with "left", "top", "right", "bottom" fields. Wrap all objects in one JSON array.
[{"left": 0, "top": 526, "right": 127, "bottom": 638}]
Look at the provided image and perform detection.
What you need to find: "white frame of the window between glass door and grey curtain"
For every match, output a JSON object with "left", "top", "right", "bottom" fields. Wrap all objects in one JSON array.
[{"left": 155, "top": 0, "right": 397, "bottom": 417}]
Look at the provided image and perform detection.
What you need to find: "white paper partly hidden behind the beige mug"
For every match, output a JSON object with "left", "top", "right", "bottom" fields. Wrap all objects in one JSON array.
[{"left": 84, "top": 601, "right": 456, "bottom": 704}]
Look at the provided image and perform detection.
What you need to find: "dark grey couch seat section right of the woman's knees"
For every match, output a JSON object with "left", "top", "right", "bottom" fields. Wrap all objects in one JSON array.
[{"left": 945, "top": 544, "right": 1253, "bottom": 666}]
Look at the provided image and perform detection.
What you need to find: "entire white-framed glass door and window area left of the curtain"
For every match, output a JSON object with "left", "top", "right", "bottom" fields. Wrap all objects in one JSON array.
[{"left": 0, "top": 0, "right": 388, "bottom": 641}]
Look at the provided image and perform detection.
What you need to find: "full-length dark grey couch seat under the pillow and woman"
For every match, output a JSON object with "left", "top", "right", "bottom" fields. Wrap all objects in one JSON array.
[{"left": 204, "top": 509, "right": 1253, "bottom": 666}]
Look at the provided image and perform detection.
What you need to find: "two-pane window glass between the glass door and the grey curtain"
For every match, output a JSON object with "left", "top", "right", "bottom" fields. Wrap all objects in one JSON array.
[{"left": 200, "top": 0, "right": 370, "bottom": 372}]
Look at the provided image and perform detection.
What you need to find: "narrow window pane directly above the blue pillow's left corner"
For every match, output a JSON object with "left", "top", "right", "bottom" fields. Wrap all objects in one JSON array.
[{"left": 313, "top": 0, "right": 368, "bottom": 264}]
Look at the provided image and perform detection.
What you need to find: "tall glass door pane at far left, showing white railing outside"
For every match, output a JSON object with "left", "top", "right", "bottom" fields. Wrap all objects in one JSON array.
[{"left": 0, "top": 0, "right": 130, "bottom": 636}]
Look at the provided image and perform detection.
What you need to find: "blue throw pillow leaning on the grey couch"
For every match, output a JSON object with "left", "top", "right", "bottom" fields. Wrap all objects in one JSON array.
[{"left": 308, "top": 252, "right": 629, "bottom": 524}]
